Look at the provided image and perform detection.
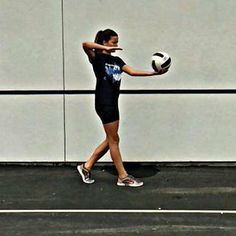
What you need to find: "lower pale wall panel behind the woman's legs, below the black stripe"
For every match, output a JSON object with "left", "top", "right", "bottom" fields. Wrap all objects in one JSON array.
[{"left": 66, "top": 95, "right": 236, "bottom": 162}]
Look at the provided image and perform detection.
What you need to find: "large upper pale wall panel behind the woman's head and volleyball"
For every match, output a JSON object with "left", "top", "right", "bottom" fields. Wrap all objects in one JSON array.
[{"left": 65, "top": 0, "right": 236, "bottom": 89}]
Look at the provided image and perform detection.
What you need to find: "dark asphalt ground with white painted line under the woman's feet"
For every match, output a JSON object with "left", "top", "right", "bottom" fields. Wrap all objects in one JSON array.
[{"left": 0, "top": 163, "right": 236, "bottom": 236}]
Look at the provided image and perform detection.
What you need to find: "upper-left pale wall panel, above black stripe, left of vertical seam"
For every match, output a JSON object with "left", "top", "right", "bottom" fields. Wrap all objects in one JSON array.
[{"left": 0, "top": 0, "right": 63, "bottom": 90}]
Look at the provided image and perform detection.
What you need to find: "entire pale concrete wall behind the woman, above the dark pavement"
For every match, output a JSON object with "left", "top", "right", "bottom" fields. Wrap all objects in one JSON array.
[{"left": 0, "top": 0, "right": 236, "bottom": 161}]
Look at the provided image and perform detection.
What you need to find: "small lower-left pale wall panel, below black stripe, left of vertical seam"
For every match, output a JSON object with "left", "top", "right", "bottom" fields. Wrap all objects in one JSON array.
[{"left": 0, "top": 95, "right": 64, "bottom": 162}]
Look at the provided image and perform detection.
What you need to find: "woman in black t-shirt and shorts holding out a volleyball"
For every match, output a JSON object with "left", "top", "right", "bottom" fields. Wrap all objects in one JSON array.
[{"left": 77, "top": 29, "right": 166, "bottom": 187}]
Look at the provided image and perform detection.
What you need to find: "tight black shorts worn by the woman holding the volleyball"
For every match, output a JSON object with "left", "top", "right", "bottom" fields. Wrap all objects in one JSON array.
[{"left": 95, "top": 104, "right": 120, "bottom": 124}]
